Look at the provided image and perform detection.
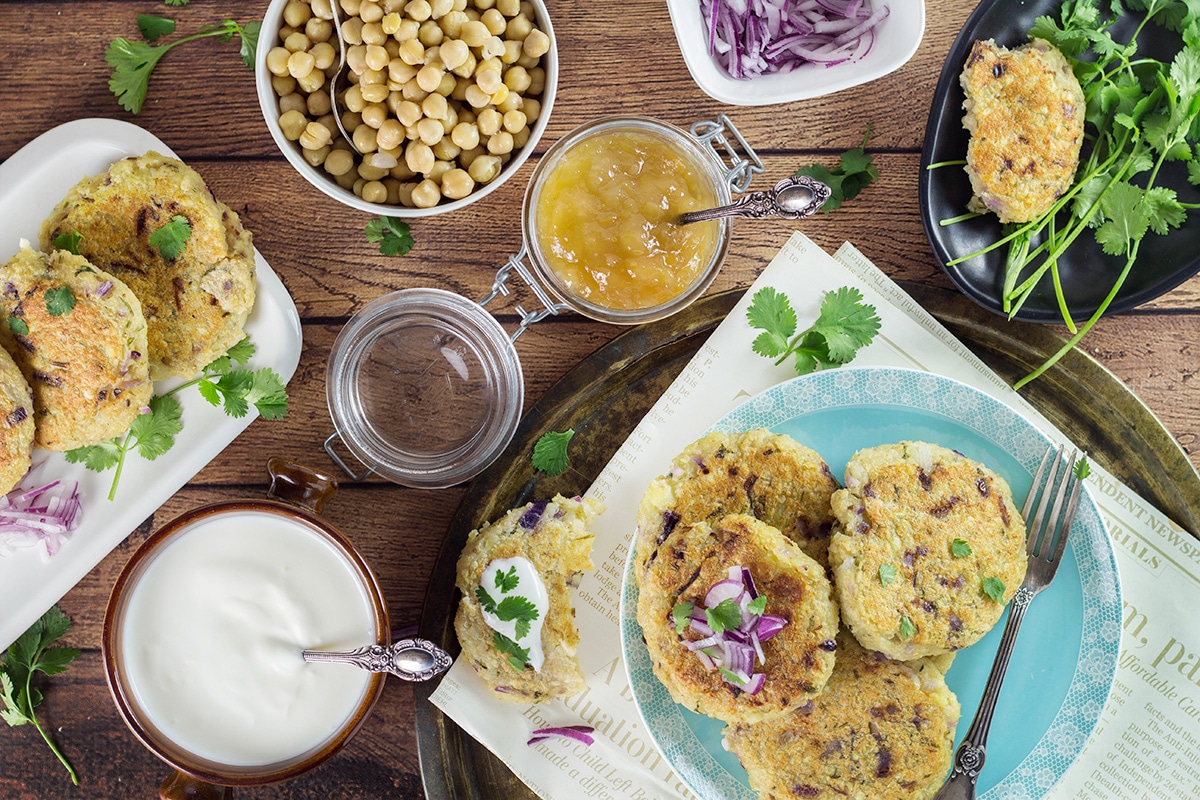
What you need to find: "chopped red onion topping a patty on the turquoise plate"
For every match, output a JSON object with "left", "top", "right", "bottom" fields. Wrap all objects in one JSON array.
[{"left": 672, "top": 566, "right": 787, "bottom": 694}]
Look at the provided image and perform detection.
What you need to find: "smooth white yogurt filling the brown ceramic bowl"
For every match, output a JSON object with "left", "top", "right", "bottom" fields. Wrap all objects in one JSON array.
[{"left": 121, "top": 511, "right": 374, "bottom": 766}]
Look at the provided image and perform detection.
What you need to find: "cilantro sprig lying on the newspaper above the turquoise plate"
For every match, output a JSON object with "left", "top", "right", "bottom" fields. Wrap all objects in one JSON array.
[{"left": 746, "top": 287, "right": 880, "bottom": 375}]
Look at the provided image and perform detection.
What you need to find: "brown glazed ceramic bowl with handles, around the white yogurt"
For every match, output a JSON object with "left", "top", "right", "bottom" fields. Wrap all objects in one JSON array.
[{"left": 102, "top": 459, "right": 391, "bottom": 798}]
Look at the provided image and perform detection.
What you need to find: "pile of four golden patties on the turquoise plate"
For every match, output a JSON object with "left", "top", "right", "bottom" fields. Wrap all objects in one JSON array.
[{"left": 635, "top": 429, "right": 1026, "bottom": 800}]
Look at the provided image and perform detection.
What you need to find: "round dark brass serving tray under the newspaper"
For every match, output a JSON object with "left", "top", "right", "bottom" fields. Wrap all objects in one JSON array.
[{"left": 416, "top": 283, "right": 1200, "bottom": 800}]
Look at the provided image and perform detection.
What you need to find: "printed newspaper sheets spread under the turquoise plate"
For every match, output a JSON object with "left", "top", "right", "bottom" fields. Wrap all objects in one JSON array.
[{"left": 431, "top": 233, "right": 1200, "bottom": 800}]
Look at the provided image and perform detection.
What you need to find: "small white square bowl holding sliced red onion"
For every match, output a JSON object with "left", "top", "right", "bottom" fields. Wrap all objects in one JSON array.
[{"left": 667, "top": 0, "right": 925, "bottom": 106}]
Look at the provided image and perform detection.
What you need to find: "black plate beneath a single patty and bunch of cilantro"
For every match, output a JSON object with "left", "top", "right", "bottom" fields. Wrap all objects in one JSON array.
[{"left": 920, "top": 0, "right": 1200, "bottom": 323}]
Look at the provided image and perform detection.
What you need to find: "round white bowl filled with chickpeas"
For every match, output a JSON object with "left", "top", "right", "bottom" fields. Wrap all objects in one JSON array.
[{"left": 256, "top": 0, "right": 558, "bottom": 217}]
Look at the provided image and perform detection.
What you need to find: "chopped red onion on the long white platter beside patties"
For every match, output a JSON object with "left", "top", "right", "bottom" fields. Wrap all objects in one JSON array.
[{"left": 0, "top": 481, "right": 80, "bottom": 560}]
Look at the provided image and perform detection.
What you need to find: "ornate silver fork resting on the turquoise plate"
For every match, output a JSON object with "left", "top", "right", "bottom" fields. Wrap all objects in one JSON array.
[{"left": 934, "top": 447, "right": 1082, "bottom": 800}]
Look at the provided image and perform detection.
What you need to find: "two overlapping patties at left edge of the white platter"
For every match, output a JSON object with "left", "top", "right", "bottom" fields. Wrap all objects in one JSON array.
[{"left": 0, "top": 242, "right": 154, "bottom": 470}]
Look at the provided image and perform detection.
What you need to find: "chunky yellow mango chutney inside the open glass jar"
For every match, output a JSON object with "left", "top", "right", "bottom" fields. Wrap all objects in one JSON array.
[{"left": 530, "top": 127, "right": 727, "bottom": 312}]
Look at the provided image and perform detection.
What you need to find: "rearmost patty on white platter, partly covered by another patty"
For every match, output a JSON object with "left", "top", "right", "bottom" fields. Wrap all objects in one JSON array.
[{"left": 41, "top": 151, "right": 254, "bottom": 380}]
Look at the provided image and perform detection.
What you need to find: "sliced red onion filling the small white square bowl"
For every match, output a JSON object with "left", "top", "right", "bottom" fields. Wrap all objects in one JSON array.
[{"left": 700, "top": 0, "right": 888, "bottom": 79}]
